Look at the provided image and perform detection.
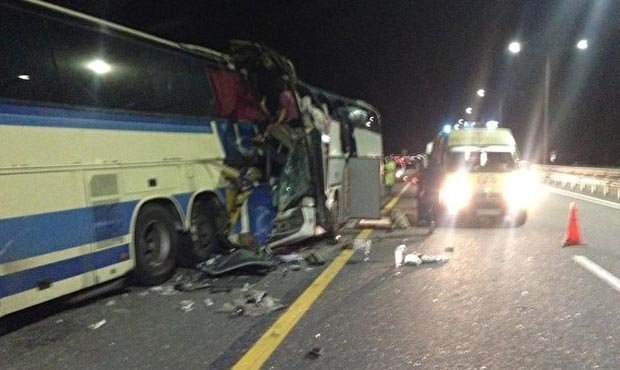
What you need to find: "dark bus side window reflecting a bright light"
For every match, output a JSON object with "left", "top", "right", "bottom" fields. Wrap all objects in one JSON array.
[{"left": 50, "top": 16, "right": 214, "bottom": 116}]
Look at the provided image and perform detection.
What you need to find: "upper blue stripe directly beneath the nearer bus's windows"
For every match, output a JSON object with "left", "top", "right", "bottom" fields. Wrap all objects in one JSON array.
[{"left": 0, "top": 104, "right": 218, "bottom": 133}]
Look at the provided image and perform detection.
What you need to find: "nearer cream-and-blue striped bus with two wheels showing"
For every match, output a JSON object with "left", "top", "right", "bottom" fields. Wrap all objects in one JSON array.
[{"left": 0, "top": 1, "right": 236, "bottom": 316}]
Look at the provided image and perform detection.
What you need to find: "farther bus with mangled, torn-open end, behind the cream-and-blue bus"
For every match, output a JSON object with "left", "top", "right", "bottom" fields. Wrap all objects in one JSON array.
[{"left": 218, "top": 41, "right": 383, "bottom": 247}]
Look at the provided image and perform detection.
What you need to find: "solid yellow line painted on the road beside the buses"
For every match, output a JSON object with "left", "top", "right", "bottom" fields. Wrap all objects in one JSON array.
[{"left": 232, "top": 183, "right": 409, "bottom": 370}]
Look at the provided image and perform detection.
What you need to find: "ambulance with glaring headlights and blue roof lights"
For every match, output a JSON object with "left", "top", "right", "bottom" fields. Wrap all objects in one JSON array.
[{"left": 432, "top": 126, "right": 537, "bottom": 226}]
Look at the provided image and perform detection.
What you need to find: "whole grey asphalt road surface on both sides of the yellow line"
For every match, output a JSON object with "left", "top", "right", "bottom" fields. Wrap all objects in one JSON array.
[{"left": 0, "top": 184, "right": 620, "bottom": 369}]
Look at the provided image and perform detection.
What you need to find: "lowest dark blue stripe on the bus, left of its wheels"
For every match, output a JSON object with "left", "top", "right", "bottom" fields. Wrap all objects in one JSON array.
[{"left": 0, "top": 244, "right": 129, "bottom": 298}]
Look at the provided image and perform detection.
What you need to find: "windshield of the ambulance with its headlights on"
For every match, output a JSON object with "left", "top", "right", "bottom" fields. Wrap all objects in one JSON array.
[{"left": 446, "top": 151, "right": 516, "bottom": 172}]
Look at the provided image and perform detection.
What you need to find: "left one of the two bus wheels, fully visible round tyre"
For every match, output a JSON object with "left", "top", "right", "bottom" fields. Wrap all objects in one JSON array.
[{"left": 134, "top": 204, "right": 179, "bottom": 285}]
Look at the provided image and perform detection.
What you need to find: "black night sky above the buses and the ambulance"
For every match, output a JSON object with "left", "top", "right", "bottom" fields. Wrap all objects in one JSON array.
[{"left": 51, "top": 0, "right": 620, "bottom": 166}]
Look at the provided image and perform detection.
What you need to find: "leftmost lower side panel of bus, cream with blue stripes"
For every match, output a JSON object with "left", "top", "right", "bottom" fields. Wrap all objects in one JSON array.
[{"left": 0, "top": 169, "right": 94, "bottom": 314}]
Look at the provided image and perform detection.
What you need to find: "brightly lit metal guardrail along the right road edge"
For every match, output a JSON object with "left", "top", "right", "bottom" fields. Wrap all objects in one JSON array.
[{"left": 532, "top": 165, "right": 620, "bottom": 202}]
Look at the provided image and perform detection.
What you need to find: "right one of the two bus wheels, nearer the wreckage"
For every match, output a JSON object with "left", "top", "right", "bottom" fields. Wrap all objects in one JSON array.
[{"left": 179, "top": 198, "right": 226, "bottom": 266}]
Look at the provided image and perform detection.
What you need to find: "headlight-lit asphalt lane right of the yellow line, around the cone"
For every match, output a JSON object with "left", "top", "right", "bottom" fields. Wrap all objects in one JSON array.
[{"left": 265, "top": 188, "right": 620, "bottom": 369}]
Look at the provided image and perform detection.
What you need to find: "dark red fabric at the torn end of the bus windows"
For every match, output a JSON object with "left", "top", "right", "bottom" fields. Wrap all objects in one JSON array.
[{"left": 209, "top": 68, "right": 259, "bottom": 121}]
